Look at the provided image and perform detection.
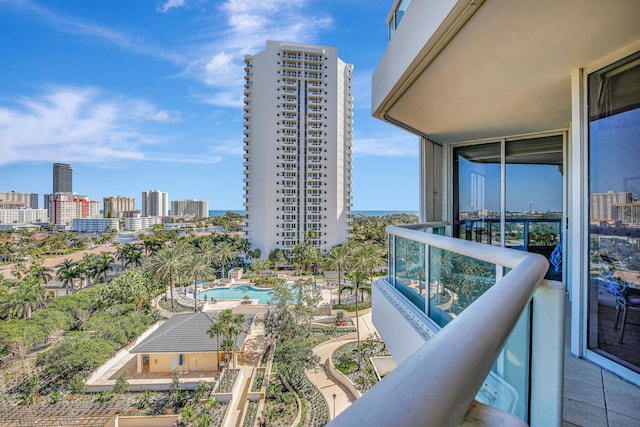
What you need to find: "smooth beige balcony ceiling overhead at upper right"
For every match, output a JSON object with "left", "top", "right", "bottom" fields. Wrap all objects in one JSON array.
[{"left": 374, "top": 0, "right": 640, "bottom": 143}]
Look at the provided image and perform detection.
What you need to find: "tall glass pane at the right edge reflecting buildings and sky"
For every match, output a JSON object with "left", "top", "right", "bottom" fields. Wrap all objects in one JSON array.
[{"left": 587, "top": 49, "right": 640, "bottom": 372}]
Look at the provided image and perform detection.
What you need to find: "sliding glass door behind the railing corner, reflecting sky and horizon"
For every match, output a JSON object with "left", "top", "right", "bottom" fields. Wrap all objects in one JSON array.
[{"left": 453, "top": 133, "right": 565, "bottom": 280}]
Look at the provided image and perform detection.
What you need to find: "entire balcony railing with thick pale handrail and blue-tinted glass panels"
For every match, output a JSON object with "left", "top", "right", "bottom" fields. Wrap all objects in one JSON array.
[{"left": 331, "top": 224, "right": 564, "bottom": 427}]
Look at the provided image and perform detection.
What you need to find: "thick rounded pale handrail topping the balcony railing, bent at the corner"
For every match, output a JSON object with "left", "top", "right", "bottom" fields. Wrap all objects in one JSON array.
[{"left": 330, "top": 224, "right": 549, "bottom": 427}]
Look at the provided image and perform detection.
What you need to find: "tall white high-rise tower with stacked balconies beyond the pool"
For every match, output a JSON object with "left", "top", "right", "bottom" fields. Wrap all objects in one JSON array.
[{"left": 244, "top": 41, "right": 353, "bottom": 256}]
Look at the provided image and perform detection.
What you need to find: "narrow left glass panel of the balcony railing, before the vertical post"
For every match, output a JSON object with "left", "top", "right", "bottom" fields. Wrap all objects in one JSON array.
[{"left": 393, "top": 236, "right": 426, "bottom": 311}]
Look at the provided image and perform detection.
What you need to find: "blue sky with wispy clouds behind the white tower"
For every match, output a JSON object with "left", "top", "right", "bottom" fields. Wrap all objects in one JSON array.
[{"left": 0, "top": 0, "right": 418, "bottom": 210}]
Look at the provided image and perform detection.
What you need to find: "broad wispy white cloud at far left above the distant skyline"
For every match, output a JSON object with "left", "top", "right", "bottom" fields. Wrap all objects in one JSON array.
[{"left": 0, "top": 87, "right": 185, "bottom": 165}]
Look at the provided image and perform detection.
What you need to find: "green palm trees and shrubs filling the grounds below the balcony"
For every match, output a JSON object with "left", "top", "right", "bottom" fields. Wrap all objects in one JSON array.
[{"left": 0, "top": 214, "right": 420, "bottom": 426}]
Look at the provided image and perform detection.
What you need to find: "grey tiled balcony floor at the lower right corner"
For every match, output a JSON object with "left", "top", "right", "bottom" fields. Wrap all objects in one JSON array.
[{"left": 563, "top": 304, "right": 640, "bottom": 427}]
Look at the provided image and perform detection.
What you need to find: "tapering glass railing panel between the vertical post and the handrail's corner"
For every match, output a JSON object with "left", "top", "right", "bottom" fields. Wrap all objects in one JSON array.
[{"left": 428, "top": 247, "right": 496, "bottom": 327}]
